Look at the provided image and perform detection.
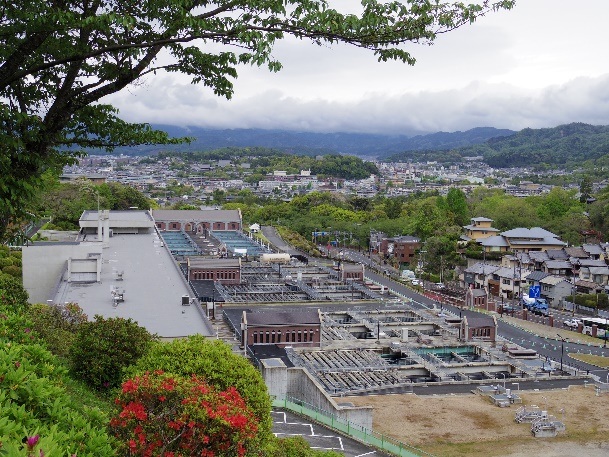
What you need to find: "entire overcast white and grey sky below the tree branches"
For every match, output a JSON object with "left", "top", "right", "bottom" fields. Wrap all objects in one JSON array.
[{"left": 107, "top": 0, "right": 609, "bottom": 134}]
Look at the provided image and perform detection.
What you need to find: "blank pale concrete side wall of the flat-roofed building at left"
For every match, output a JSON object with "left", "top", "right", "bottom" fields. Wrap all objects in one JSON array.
[{"left": 22, "top": 243, "right": 102, "bottom": 303}]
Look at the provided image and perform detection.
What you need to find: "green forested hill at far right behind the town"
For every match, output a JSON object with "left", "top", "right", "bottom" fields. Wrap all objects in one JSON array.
[{"left": 385, "top": 123, "right": 609, "bottom": 168}]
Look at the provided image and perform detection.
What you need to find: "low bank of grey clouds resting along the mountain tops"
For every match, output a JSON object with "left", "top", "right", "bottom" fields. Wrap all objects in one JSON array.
[{"left": 107, "top": 69, "right": 609, "bottom": 133}]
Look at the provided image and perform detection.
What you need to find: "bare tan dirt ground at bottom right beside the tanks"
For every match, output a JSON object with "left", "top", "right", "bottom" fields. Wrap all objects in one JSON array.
[{"left": 349, "top": 386, "right": 609, "bottom": 457}]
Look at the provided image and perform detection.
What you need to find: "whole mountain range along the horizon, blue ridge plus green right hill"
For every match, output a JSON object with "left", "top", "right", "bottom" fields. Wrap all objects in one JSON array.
[{"left": 100, "top": 122, "right": 609, "bottom": 168}]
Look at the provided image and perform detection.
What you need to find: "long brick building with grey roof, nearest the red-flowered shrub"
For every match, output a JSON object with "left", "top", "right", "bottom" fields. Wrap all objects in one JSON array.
[{"left": 241, "top": 310, "right": 321, "bottom": 348}]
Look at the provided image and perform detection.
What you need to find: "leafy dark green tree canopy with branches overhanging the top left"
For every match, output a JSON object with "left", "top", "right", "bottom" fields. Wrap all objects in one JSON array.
[{"left": 0, "top": 0, "right": 514, "bottom": 239}]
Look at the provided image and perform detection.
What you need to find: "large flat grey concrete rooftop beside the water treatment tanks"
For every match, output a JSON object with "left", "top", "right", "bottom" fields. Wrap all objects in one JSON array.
[{"left": 54, "top": 233, "right": 213, "bottom": 338}]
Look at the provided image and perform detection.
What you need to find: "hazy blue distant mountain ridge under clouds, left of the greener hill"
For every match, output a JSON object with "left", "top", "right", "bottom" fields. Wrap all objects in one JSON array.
[{"left": 98, "top": 125, "right": 515, "bottom": 159}]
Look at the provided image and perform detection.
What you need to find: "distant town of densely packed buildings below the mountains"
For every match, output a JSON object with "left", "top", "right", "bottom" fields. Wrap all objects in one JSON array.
[{"left": 60, "top": 155, "right": 607, "bottom": 206}]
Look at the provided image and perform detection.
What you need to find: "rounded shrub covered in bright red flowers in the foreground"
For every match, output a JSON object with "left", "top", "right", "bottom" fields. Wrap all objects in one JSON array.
[{"left": 110, "top": 371, "right": 258, "bottom": 457}]
